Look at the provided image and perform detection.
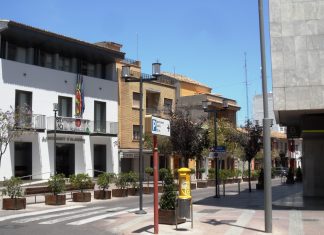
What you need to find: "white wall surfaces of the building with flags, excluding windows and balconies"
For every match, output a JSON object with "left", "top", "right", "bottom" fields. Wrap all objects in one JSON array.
[{"left": 0, "top": 59, "right": 118, "bottom": 179}]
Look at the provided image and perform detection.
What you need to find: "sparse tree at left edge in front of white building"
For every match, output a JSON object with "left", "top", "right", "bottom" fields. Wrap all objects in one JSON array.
[{"left": 0, "top": 106, "right": 31, "bottom": 166}]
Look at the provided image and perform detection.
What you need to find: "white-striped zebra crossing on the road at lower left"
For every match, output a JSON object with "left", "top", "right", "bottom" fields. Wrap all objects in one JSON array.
[{"left": 0, "top": 205, "right": 138, "bottom": 226}]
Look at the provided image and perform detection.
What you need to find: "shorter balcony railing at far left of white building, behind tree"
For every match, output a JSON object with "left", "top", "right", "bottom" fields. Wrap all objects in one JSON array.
[{"left": 16, "top": 114, "right": 45, "bottom": 130}]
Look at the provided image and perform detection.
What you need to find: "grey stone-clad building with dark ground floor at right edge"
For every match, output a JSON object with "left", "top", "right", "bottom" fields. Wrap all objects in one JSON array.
[{"left": 269, "top": 0, "right": 324, "bottom": 196}]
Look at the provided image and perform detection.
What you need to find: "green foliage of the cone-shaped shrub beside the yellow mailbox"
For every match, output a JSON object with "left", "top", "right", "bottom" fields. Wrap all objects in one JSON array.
[{"left": 159, "top": 170, "right": 177, "bottom": 210}]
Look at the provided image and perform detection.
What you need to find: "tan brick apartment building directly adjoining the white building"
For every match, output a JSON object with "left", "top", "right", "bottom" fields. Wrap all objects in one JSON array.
[{"left": 117, "top": 59, "right": 176, "bottom": 172}]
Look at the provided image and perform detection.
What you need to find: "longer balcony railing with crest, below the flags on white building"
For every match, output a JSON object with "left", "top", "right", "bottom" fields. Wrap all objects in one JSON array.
[{"left": 47, "top": 117, "right": 118, "bottom": 135}]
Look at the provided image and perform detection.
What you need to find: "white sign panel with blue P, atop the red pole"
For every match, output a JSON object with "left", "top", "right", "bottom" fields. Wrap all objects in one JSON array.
[{"left": 145, "top": 116, "right": 170, "bottom": 136}]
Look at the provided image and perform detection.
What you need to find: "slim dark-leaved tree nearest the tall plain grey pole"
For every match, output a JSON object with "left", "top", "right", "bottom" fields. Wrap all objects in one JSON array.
[{"left": 242, "top": 120, "right": 262, "bottom": 192}]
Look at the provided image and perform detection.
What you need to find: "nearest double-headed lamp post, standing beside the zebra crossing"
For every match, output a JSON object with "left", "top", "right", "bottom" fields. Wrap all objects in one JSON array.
[{"left": 122, "top": 62, "right": 161, "bottom": 214}]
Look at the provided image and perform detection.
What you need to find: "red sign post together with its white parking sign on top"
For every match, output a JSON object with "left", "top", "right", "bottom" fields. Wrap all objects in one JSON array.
[{"left": 145, "top": 116, "right": 170, "bottom": 234}]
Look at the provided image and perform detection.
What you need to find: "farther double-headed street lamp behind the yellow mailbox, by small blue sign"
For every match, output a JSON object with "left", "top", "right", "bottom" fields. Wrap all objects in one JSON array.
[{"left": 202, "top": 100, "right": 228, "bottom": 198}]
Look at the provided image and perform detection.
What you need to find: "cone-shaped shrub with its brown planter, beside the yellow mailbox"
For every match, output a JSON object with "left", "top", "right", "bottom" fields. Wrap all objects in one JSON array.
[{"left": 159, "top": 172, "right": 185, "bottom": 225}]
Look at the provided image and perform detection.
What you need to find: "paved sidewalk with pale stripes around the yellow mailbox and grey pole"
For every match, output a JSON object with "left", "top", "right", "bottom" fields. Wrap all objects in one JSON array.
[{"left": 110, "top": 181, "right": 324, "bottom": 235}]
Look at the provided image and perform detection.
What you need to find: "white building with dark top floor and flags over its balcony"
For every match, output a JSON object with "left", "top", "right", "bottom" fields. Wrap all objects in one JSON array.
[{"left": 0, "top": 20, "right": 124, "bottom": 179}]
